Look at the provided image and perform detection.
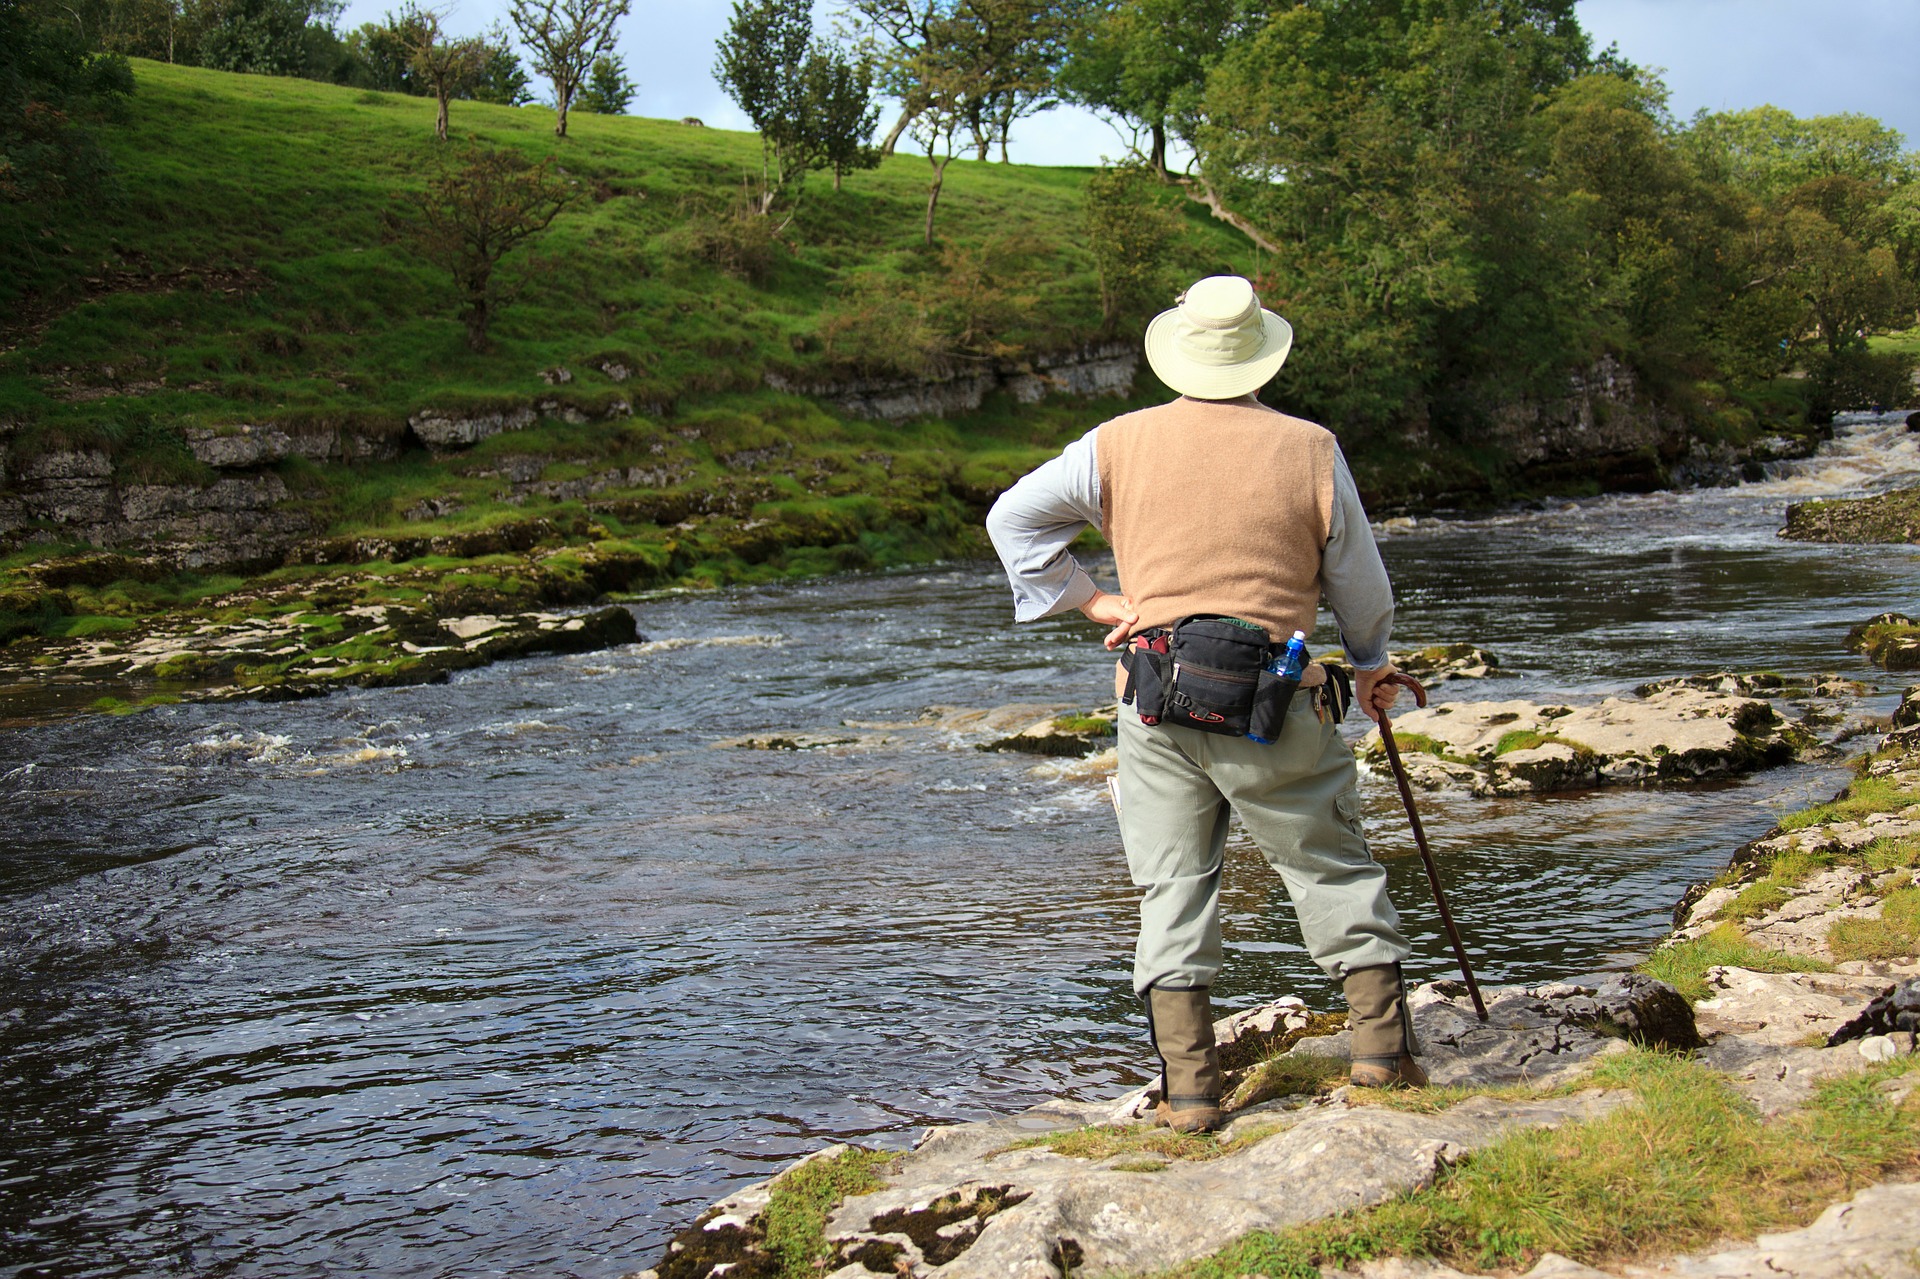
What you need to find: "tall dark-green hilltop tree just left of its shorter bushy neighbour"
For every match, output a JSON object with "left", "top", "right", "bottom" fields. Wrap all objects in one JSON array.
[{"left": 714, "top": 0, "right": 814, "bottom": 213}]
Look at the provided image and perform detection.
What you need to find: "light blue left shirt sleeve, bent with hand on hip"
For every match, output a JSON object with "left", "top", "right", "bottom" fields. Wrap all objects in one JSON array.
[{"left": 987, "top": 426, "right": 1100, "bottom": 622}]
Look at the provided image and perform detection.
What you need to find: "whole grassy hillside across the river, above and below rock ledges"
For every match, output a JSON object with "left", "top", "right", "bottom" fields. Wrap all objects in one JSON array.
[{"left": 0, "top": 61, "right": 1274, "bottom": 657}]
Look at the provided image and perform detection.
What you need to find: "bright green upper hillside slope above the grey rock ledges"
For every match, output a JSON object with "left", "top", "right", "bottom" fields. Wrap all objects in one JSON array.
[{"left": 0, "top": 61, "right": 1246, "bottom": 447}]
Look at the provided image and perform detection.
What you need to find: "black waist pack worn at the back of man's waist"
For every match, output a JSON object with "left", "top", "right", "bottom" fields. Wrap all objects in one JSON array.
[{"left": 1119, "top": 613, "right": 1300, "bottom": 741}]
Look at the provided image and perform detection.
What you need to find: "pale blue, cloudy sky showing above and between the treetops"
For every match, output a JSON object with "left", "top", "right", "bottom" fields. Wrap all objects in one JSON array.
[{"left": 340, "top": 0, "right": 1920, "bottom": 165}]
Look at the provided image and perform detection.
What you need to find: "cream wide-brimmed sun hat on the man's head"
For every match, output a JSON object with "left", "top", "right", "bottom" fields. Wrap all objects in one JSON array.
[{"left": 1146, "top": 275, "right": 1294, "bottom": 399}]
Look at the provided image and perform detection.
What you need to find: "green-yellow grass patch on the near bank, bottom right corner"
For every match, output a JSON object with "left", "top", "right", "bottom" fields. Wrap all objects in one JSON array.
[{"left": 1173, "top": 1050, "right": 1920, "bottom": 1279}]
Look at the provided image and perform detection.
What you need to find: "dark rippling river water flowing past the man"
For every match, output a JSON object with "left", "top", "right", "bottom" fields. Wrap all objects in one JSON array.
[{"left": 0, "top": 419, "right": 1920, "bottom": 1277}]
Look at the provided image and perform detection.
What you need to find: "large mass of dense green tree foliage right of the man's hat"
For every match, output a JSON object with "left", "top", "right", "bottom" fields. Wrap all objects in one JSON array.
[{"left": 1090, "top": 0, "right": 1920, "bottom": 446}]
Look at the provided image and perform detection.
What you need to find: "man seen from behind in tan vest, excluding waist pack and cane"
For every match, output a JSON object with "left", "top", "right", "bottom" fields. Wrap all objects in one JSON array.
[{"left": 987, "top": 277, "right": 1427, "bottom": 1131}]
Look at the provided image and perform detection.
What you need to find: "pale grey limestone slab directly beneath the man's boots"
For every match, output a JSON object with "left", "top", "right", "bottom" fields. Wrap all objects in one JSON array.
[{"left": 641, "top": 976, "right": 1904, "bottom": 1279}]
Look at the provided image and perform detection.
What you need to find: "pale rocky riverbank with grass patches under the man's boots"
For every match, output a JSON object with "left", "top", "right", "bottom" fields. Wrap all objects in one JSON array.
[{"left": 639, "top": 699, "right": 1920, "bottom": 1279}]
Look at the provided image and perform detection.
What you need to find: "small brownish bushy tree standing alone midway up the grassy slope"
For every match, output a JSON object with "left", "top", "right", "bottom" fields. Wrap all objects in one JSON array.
[{"left": 417, "top": 146, "right": 574, "bottom": 351}]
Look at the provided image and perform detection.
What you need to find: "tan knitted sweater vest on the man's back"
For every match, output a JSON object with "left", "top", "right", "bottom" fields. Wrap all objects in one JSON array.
[{"left": 1094, "top": 398, "right": 1336, "bottom": 640}]
